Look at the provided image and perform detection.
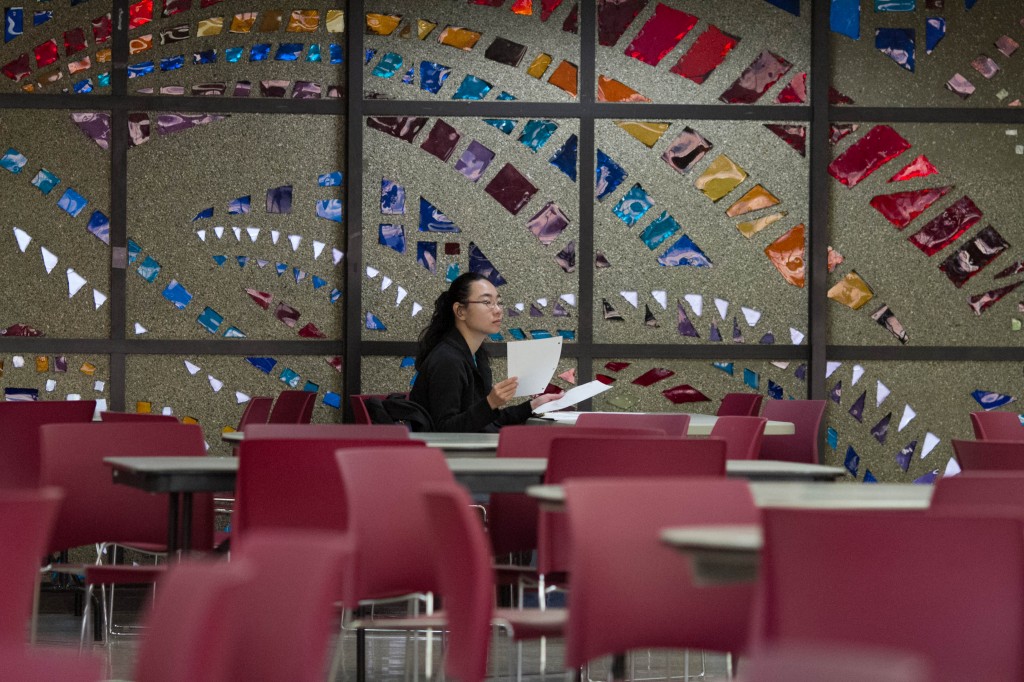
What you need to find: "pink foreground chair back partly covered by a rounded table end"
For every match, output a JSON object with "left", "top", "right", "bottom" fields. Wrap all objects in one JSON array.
[{"left": 565, "top": 478, "right": 761, "bottom": 669}]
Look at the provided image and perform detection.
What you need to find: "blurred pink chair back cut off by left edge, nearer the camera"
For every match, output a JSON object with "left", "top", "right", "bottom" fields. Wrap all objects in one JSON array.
[{"left": 0, "top": 487, "right": 63, "bottom": 644}]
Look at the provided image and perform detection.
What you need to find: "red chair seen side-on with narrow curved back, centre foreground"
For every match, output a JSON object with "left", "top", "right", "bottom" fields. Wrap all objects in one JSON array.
[{"left": 422, "top": 484, "right": 565, "bottom": 682}]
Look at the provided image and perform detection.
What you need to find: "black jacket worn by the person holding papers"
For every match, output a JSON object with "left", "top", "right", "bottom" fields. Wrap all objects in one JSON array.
[{"left": 409, "top": 330, "right": 532, "bottom": 432}]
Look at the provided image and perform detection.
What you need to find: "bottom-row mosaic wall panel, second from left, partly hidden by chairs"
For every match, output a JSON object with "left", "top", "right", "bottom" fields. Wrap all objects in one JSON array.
[{"left": 125, "top": 355, "right": 344, "bottom": 455}]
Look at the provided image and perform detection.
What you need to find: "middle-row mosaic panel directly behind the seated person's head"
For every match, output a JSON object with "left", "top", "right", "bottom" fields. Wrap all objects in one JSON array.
[{"left": 362, "top": 117, "right": 580, "bottom": 341}]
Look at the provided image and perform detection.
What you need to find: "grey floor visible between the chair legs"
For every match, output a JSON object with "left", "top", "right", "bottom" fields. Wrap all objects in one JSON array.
[{"left": 38, "top": 591, "right": 726, "bottom": 682}]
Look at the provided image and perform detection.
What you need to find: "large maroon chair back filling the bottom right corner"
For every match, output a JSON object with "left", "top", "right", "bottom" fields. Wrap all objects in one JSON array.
[{"left": 759, "top": 509, "right": 1024, "bottom": 682}]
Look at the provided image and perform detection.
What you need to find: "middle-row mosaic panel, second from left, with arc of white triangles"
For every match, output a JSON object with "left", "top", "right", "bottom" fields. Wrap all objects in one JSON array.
[{"left": 126, "top": 113, "right": 345, "bottom": 342}]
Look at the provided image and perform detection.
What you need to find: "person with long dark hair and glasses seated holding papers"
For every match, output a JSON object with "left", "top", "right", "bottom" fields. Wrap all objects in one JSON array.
[{"left": 409, "top": 272, "right": 559, "bottom": 432}]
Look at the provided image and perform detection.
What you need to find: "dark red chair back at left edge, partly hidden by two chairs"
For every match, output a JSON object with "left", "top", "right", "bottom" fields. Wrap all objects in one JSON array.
[{"left": 0, "top": 400, "right": 96, "bottom": 487}]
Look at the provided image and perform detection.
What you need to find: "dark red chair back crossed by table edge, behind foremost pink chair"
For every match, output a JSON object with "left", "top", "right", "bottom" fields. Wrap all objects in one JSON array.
[{"left": 537, "top": 436, "right": 726, "bottom": 574}]
